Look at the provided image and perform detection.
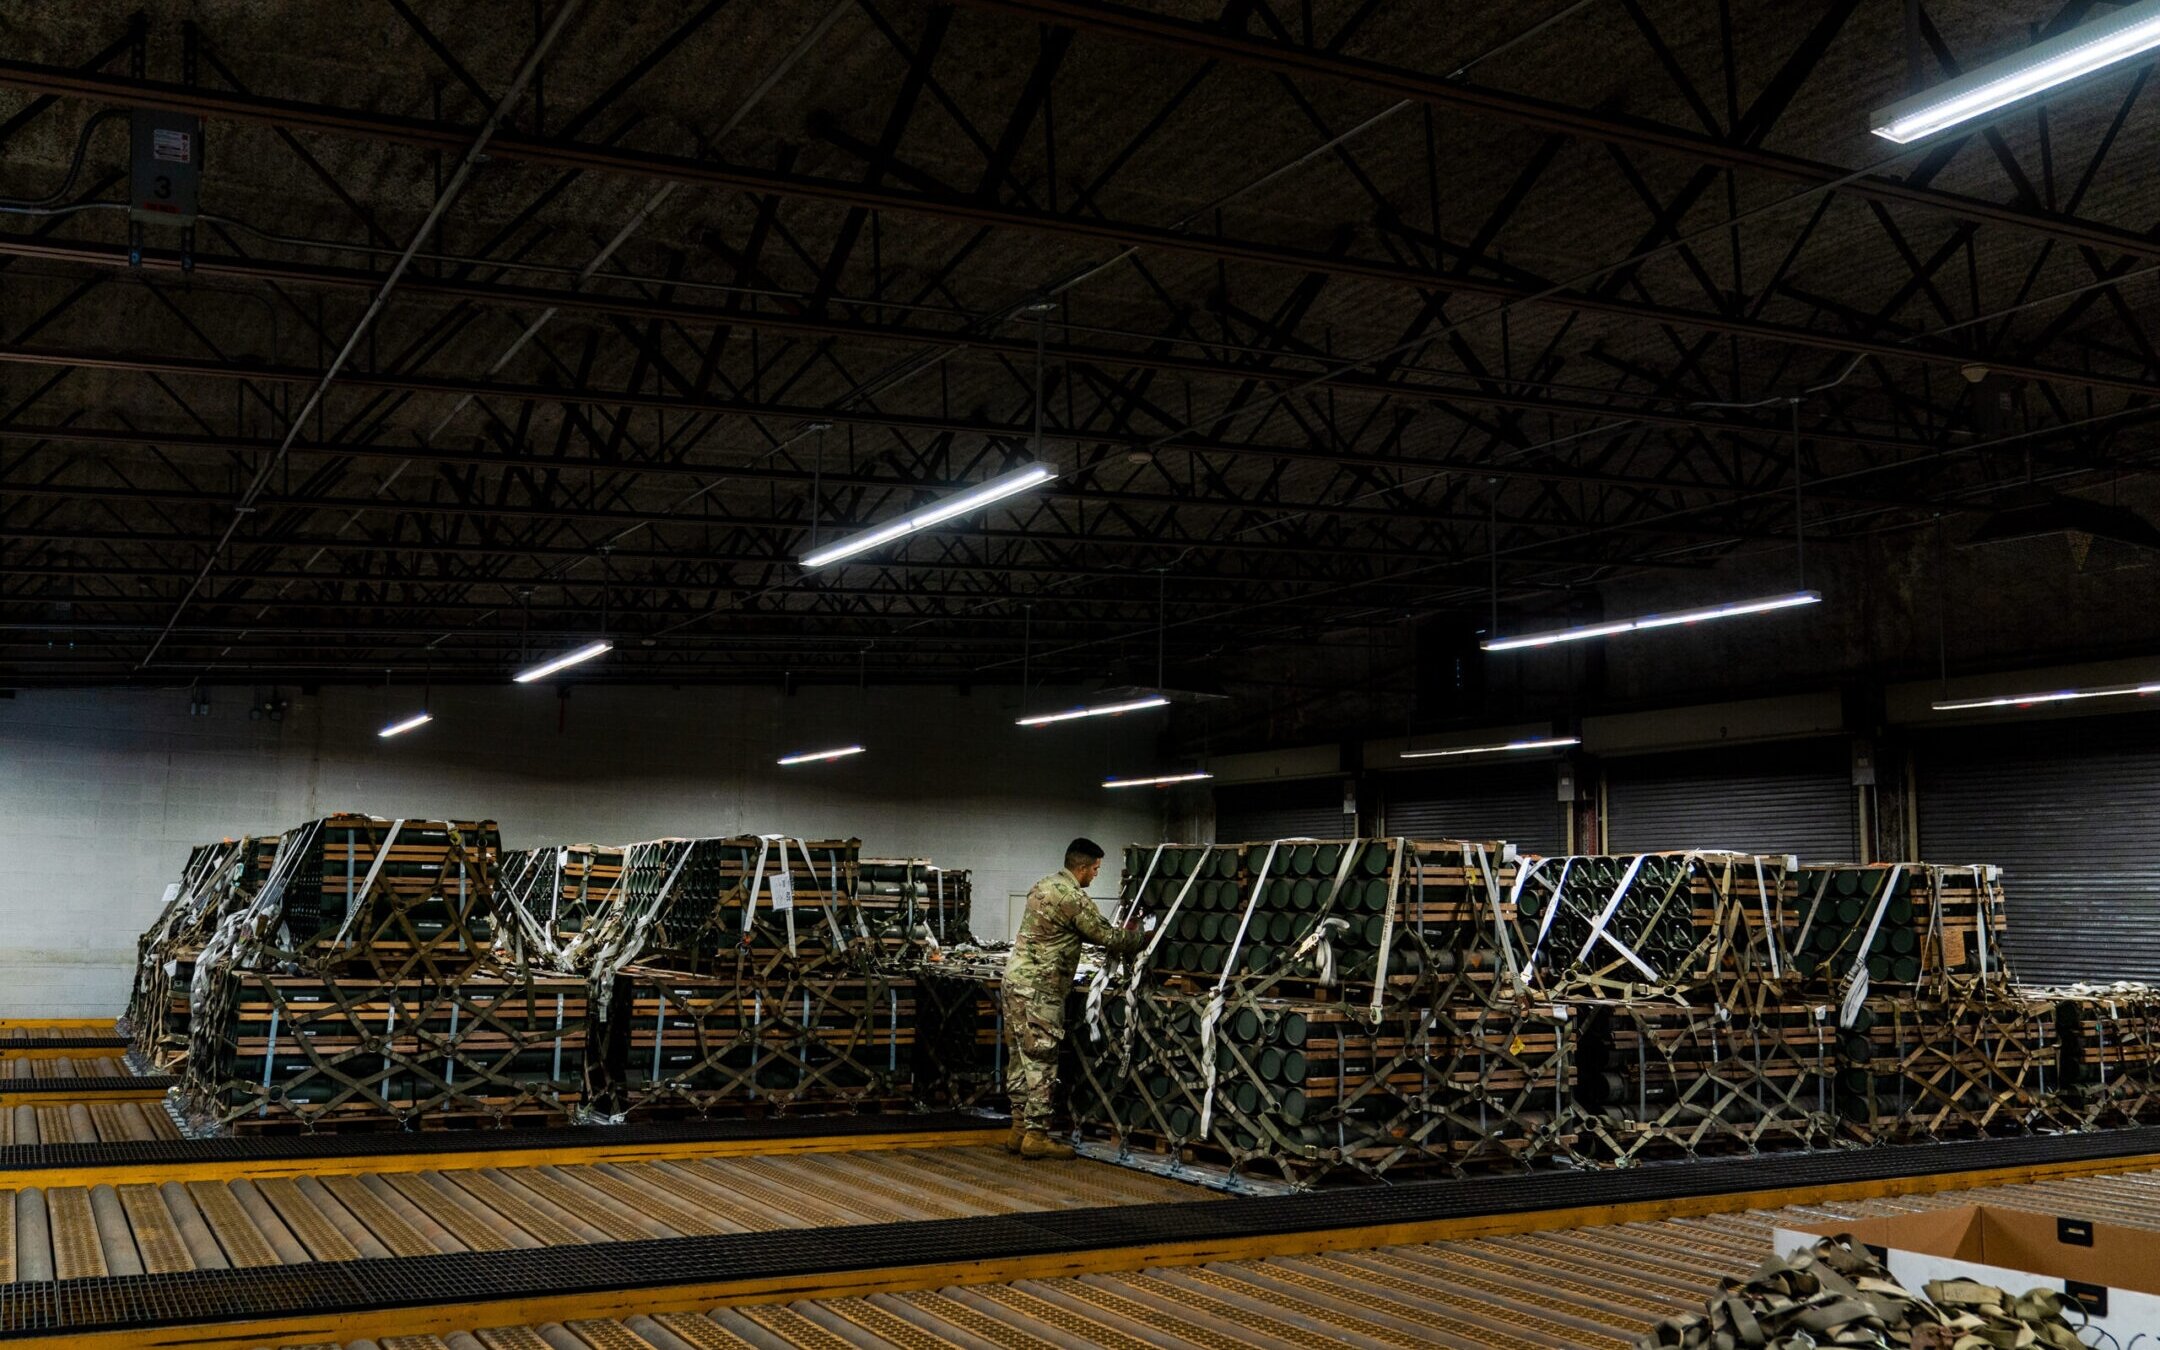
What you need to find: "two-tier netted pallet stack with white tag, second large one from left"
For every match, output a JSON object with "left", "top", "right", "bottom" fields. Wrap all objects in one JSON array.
[{"left": 579, "top": 836, "right": 916, "bottom": 1119}]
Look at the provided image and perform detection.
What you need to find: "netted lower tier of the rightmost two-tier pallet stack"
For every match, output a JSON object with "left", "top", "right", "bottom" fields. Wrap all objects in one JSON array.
[{"left": 1834, "top": 978, "right": 2061, "bottom": 1143}]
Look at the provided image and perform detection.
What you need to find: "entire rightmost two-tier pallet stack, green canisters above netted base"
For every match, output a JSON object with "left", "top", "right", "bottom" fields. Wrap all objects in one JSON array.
[{"left": 1788, "top": 862, "right": 2058, "bottom": 1143}]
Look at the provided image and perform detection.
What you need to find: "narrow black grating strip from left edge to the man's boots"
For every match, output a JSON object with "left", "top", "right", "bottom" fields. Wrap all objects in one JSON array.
[{"left": 0, "top": 1105, "right": 1004, "bottom": 1171}]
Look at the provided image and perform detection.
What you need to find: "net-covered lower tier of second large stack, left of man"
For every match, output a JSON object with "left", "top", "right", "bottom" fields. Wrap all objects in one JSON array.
[{"left": 594, "top": 961, "right": 918, "bottom": 1119}]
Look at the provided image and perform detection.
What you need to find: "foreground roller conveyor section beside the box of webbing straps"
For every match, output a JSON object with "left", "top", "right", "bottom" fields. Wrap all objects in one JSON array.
[{"left": 252, "top": 1173, "right": 2160, "bottom": 1350}]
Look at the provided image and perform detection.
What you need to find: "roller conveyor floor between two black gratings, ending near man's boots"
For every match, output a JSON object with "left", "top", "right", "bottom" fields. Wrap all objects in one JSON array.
[{"left": 0, "top": 1147, "right": 1205, "bottom": 1281}]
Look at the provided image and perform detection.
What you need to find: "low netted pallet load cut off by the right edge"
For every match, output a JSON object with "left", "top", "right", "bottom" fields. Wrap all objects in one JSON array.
[{"left": 2020, "top": 983, "right": 2160, "bottom": 1130}]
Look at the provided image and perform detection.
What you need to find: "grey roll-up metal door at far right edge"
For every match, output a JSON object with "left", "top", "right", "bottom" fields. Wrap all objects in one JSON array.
[{"left": 1916, "top": 713, "right": 2160, "bottom": 983}]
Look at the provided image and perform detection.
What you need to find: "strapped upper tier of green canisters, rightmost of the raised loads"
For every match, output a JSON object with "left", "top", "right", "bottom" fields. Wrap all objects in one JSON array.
[{"left": 1786, "top": 862, "right": 2013, "bottom": 998}]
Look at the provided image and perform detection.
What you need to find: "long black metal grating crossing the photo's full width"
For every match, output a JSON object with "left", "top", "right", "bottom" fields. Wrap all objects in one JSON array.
[{"left": 0, "top": 1128, "right": 2160, "bottom": 1339}]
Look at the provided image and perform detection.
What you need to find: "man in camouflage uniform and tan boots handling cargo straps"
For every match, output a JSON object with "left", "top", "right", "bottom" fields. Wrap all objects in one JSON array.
[{"left": 1004, "top": 838, "right": 1145, "bottom": 1158}]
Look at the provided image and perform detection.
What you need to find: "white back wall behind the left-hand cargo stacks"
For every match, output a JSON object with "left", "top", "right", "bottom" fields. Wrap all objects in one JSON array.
[{"left": 0, "top": 687, "right": 1162, "bottom": 1017}]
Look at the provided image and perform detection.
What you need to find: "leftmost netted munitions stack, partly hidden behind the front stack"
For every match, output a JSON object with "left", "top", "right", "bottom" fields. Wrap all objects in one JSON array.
[{"left": 125, "top": 836, "right": 279, "bottom": 1074}]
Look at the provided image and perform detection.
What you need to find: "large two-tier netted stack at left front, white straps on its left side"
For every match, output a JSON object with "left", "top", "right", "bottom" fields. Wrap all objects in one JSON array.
[{"left": 177, "top": 814, "right": 588, "bottom": 1134}]
